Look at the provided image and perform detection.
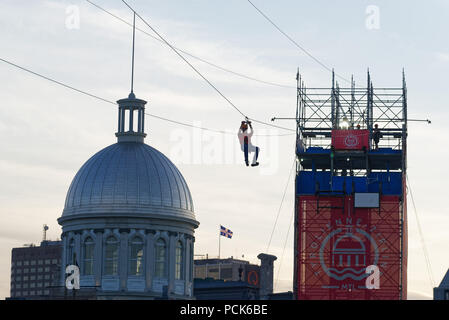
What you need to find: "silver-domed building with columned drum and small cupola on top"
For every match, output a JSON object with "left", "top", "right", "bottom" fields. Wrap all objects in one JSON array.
[{"left": 58, "top": 92, "right": 199, "bottom": 299}]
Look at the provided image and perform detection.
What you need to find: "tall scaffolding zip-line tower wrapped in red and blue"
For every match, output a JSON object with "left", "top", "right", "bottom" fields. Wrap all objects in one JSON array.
[{"left": 288, "top": 71, "right": 407, "bottom": 299}]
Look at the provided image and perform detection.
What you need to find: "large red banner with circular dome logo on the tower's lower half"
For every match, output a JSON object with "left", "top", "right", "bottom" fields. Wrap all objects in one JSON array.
[{"left": 296, "top": 196, "right": 407, "bottom": 300}]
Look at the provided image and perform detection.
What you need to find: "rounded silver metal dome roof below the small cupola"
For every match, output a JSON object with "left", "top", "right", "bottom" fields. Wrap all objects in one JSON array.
[{"left": 63, "top": 142, "right": 194, "bottom": 219}]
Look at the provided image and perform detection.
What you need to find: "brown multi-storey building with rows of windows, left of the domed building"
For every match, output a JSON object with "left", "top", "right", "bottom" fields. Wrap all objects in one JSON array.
[{"left": 10, "top": 241, "right": 62, "bottom": 299}]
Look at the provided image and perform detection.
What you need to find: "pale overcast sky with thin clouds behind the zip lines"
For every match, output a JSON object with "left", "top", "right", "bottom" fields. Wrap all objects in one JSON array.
[{"left": 0, "top": 0, "right": 449, "bottom": 298}]
